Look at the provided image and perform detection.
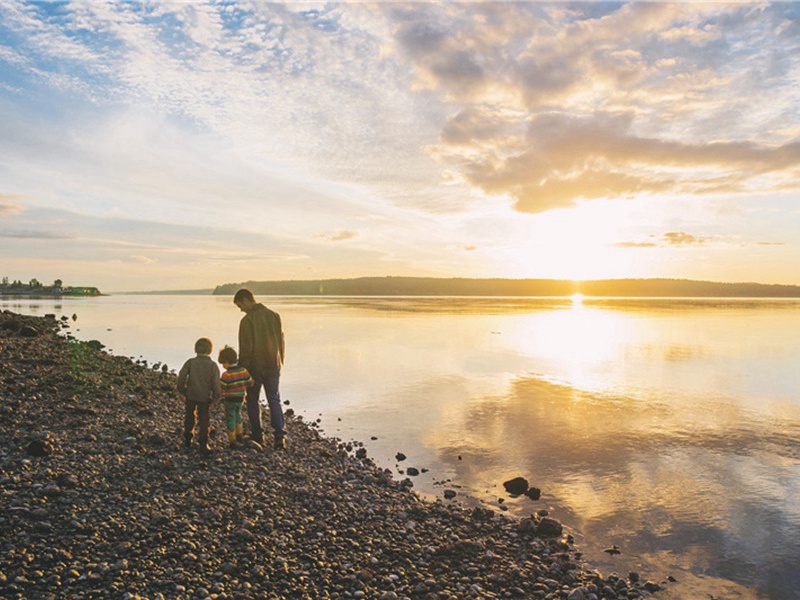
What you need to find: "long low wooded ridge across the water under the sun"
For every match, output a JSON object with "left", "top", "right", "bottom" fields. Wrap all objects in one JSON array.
[{"left": 214, "top": 277, "right": 800, "bottom": 298}]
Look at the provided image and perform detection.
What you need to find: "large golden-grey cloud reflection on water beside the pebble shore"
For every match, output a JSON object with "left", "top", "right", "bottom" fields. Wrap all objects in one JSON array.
[{"left": 427, "top": 378, "right": 800, "bottom": 597}]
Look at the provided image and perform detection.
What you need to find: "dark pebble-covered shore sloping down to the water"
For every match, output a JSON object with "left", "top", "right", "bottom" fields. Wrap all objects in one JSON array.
[{"left": 0, "top": 312, "right": 656, "bottom": 600}]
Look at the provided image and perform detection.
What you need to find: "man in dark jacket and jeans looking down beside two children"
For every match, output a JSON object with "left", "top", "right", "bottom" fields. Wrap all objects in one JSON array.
[{"left": 233, "top": 288, "right": 286, "bottom": 449}]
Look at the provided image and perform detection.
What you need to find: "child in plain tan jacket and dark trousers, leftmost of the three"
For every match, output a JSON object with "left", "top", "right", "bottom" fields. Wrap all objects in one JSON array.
[{"left": 178, "top": 338, "right": 220, "bottom": 456}]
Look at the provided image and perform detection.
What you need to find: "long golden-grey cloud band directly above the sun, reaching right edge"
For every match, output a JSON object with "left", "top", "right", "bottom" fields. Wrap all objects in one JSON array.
[{"left": 446, "top": 113, "right": 800, "bottom": 212}]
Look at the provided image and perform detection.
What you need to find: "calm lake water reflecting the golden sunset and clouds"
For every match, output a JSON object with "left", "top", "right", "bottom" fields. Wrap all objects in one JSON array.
[{"left": 0, "top": 295, "right": 800, "bottom": 599}]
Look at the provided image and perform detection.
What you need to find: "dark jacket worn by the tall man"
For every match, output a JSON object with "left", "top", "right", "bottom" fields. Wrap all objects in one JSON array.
[{"left": 239, "top": 303, "right": 286, "bottom": 376}]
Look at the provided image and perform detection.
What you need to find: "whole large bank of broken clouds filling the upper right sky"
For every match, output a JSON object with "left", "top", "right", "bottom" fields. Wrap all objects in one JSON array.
[{"left": 396, "top": 3, "right": 800, "bottom": 213}]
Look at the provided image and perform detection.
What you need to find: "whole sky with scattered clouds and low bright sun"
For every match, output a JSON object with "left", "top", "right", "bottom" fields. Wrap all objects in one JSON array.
[{"left": 0, "top": 0, "right": 800, "bottom": 292}]
